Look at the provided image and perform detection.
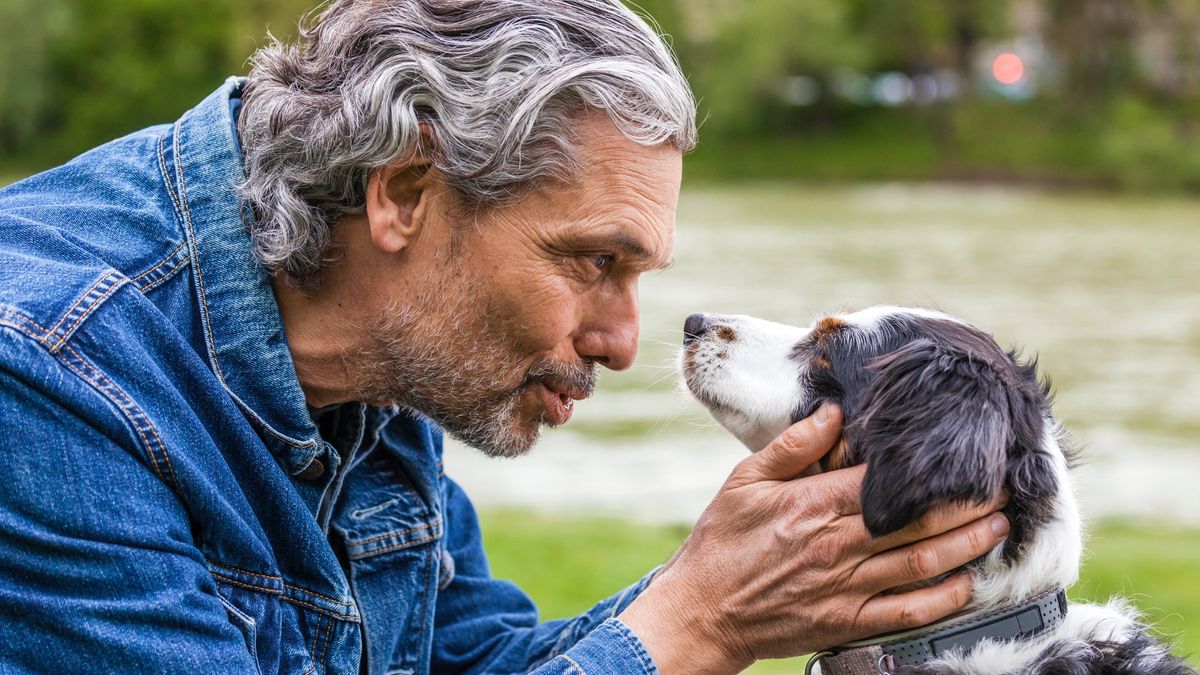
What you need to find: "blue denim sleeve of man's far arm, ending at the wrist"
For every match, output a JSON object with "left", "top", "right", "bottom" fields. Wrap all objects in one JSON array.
[{"left": 432, "top": 479, "right": 658, "bottom": 675}]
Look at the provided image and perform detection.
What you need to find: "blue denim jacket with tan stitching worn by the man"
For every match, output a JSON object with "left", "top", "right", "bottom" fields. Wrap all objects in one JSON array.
[{"left": 0, "top": 79, "right": 655, "bottom": 675}]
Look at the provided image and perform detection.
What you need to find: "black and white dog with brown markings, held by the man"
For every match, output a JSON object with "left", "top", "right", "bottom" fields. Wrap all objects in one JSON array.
[{"left": 680, "top": 306, "right": 1195, "bottom": 675}]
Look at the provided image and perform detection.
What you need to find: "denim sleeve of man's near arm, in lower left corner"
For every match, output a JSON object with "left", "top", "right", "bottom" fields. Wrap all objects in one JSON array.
[{"left": 0, "top": 325, "right": 256, "bottom": 673}]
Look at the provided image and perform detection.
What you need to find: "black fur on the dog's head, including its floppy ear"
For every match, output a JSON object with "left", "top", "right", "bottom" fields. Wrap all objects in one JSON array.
[{"left": 796, "top": 315, "right": 1058, "bottom": 560}]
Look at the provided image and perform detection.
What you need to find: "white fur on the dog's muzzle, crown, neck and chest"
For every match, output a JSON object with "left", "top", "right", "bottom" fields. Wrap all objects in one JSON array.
[{"left": 680, "top": 305, "right": 1176, "bottom": 675}]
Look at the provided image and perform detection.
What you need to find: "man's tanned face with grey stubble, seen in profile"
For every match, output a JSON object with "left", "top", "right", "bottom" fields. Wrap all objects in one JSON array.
[{"left": 347, "top": 118, "right": 682, "bottom": 456}]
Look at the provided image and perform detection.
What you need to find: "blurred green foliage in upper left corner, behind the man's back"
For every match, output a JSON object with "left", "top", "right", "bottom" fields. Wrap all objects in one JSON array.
[{"left": 0, "top": 0, "right": 308, "bottom": 166}]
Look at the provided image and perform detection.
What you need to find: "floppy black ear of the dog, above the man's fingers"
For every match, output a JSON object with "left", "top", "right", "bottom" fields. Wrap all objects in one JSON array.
[{"left": 845, "top": 340, "right": 1013, "bottom": 537}]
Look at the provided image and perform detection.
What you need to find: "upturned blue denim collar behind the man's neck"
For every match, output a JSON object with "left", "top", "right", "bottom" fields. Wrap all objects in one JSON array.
[{"left": 169, "top": 78, "right": 324, "bottom": 474}]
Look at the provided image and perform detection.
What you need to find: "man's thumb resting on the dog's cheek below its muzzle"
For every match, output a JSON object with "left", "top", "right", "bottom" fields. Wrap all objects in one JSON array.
[{"left": 728, "top": 402, "right": 841, "bottom": 486}]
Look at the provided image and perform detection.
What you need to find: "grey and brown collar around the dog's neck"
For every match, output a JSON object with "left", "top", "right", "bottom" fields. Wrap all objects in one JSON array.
[{"left": 804, "top": 589, "right": 1067, "bottom": 675}]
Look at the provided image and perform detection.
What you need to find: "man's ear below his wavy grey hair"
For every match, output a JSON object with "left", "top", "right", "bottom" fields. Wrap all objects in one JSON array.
[{"left": 366, "top": 157, "right": 436, "bottom": 253}]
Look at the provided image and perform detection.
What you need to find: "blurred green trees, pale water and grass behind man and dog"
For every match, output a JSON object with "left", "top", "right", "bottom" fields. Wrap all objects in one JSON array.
[{"left": 0, "top": 0, "right": 1200, "bottom": 673}]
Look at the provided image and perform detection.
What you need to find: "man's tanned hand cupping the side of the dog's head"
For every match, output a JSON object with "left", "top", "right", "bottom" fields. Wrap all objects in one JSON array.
[{"left": 620, "top": 404, "right": 1008, "bottom": 674}]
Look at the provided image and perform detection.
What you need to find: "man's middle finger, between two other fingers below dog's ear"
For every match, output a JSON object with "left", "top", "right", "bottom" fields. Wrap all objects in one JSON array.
[{"left": 854, "top": 514, "right": 1008, "bottom": 592}]
